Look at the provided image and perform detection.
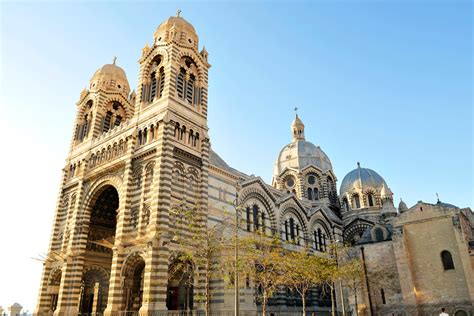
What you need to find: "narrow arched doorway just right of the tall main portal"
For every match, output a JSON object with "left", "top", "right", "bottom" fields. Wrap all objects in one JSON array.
[{"left": 123, "top": 255, "right": 145, "bottom": 312}]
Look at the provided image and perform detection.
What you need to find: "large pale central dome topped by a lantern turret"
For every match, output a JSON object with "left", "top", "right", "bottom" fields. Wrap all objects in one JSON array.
[{"left": 273, "top": 116, "right": 332, "bottom": 178}]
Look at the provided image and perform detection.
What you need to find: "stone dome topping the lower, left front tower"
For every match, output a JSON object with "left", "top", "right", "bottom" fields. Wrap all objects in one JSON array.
[{"left": 90, "top": 58, "right": 130, "bottom": 95}]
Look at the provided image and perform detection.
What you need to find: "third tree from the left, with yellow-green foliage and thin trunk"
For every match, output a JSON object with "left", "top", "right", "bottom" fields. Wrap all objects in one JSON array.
[{"left": 282, "top": 249, "right": 328, "bottom": 316}]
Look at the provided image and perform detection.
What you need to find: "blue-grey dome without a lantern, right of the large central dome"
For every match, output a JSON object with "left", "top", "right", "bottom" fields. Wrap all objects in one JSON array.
[{"left": 339, "top": 165, "right": 391, "bottom": 197}]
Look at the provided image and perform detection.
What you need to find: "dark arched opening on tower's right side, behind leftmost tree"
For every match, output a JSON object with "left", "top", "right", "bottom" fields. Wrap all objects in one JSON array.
[{"left": 166, "top": 259, "right": 194, "bottom": 311}]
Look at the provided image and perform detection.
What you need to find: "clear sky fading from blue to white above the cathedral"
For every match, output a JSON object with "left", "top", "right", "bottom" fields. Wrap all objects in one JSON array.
[{"left": 0, "top": 0, "right": 474, "bottom": 311}]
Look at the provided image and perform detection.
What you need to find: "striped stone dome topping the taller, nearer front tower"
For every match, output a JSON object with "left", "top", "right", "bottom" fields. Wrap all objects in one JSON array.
[{"left": 154, "top": 10, "right": 198, "bottom": 49}]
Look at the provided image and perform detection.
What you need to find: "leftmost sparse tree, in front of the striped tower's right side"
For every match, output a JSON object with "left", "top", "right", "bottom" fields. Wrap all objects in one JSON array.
[{"left": 169, "top": 206, "right": 230, "bottom": 316}]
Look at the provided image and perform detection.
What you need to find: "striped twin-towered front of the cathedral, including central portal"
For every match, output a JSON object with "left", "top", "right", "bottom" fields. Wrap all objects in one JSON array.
[{"left": 35, "top": 12, "right": 210, "bottom": 315}]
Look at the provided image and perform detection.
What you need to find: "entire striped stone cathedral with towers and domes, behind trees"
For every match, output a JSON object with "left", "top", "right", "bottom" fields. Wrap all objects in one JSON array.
[{"left": 35, "top": 12, "right": 474, "bottom": 316}]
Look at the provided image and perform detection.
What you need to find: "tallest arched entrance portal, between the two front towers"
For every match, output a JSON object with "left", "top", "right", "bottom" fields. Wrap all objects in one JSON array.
[{"left": 79, "top": 185, "right": 119, "bottom": 314}]
